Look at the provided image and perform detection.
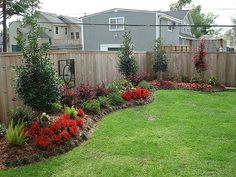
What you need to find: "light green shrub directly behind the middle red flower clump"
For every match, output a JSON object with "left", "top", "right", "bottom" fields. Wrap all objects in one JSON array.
[{"left": 107, "top": 80, "right": 133, "bottom": 92}]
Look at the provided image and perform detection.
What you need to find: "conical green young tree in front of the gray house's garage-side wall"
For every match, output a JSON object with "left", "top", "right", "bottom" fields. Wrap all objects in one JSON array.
[{"left": 118, "top": 31, "right": 138, "bottom": 78}]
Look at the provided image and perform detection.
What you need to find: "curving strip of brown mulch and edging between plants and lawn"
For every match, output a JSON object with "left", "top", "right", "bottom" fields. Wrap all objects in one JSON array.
[{"left": 0, "top": 94, "right": 154, "bottom": 169}]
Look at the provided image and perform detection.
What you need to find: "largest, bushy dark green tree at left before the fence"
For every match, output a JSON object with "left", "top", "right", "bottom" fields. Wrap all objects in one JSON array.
[{"left": 16, "top": 20, "right": 63, "bottom": 112}]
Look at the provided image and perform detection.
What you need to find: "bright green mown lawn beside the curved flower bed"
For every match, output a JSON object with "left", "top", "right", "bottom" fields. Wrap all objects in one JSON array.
[{"left": 0, "top": 90, "right": 236, "bottom": 177}]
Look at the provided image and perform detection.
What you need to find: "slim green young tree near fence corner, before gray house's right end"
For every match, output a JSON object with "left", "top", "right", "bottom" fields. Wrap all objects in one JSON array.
[{"left": 152, "top": 38, "right": 168, "bottom": 79}]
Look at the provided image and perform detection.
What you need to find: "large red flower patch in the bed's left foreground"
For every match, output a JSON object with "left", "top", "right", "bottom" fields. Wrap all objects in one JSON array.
[{"left": 25, "top": 109, "right": 85, "bottom": 149}]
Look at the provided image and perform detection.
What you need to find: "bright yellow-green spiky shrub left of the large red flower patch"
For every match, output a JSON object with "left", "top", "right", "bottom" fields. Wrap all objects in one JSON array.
[{"left": 5, "top": 121, "right": 26, "bottom": 145}]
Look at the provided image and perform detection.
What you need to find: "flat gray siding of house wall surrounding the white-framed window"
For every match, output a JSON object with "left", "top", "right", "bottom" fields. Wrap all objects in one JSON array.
[{"left": 83, "top": 10, "right": 156, "bottom": 51}]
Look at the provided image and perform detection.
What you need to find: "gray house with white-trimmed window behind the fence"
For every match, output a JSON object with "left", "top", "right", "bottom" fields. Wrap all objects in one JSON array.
[{"left": 81, "top": 9, "right": 193, "bottom": 51}]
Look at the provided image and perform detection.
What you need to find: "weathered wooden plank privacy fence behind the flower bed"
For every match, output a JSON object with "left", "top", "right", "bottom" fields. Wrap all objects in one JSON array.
[{"left": 0, "top": 51, "right": 236, "bottom": 122}]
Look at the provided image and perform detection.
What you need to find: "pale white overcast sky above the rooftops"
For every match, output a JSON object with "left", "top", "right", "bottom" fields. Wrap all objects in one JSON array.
[{"left": 41, "top": 0, "right": 236, "bottom": 25}]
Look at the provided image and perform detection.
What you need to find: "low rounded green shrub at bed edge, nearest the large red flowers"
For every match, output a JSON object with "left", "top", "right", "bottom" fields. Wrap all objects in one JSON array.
[{"left": 81, "top": 99, "right": 100, "bottom": 114}]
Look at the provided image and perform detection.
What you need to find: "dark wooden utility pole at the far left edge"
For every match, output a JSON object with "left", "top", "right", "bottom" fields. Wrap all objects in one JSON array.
[{"left": 2, "top": 0, "right": 7, "bottom": 52}]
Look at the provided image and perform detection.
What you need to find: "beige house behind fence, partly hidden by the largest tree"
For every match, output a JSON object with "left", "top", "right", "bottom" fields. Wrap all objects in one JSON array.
[{"left": 9, "top": 12, "right": 82, "bottom": 52}]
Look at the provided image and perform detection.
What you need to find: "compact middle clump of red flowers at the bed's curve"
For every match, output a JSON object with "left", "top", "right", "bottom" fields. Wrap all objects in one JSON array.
[{"left": 121, "top": 87, "right": 150, "bottom": 101}]
